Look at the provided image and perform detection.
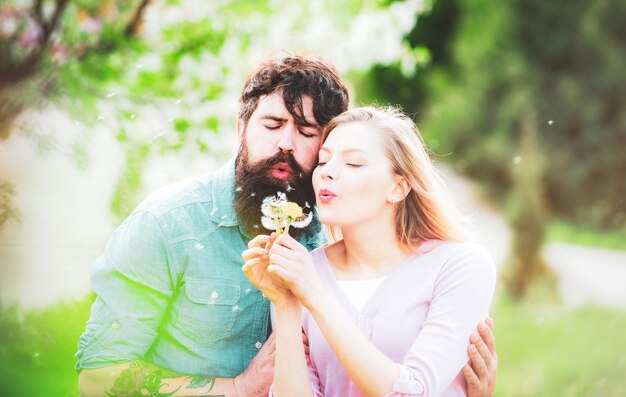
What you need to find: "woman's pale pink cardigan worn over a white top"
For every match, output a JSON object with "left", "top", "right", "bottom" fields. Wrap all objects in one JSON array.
[{"left": 270, "top": 241, "right": 496, "bottom": 397}]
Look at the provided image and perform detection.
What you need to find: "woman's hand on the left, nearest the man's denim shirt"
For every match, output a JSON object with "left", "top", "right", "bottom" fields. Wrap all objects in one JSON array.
[{"left": 241, "top": 233, "right": 296, "bottom": 305}]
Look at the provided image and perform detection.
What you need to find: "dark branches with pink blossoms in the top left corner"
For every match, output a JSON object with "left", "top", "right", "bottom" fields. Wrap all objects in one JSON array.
[{"left": 0, "top": 0, "right": 149, "bottom": 226}]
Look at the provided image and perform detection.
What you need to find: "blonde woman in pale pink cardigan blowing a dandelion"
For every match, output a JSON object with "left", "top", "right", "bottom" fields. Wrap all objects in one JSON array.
[{"left": 243, "top": 107, "right": 495, "bottom": 397}]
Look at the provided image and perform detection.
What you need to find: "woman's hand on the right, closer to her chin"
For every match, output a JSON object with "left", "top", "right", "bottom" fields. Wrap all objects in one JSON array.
[{"left": 267, "top": 234, "right": 326, "bottom": 308}]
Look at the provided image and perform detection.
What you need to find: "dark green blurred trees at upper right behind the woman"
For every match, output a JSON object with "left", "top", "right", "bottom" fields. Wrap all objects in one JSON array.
[{"left": 360, "top": 0, "right": 626, "bottom": 296}]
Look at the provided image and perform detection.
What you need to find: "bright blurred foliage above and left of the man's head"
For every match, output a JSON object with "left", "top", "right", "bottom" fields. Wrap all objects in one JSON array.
[{"left": 0, "top": 0, "right": 422, "bottom": 227}]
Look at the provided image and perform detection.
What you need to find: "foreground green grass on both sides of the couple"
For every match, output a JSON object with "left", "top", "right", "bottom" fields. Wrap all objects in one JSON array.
[{"left": 0, "top": 297, "right": 626, "bottom": 397}]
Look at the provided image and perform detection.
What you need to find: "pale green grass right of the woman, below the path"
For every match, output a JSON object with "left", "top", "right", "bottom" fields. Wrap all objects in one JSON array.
[{"left": 492, "top": 298, "right": 626, "bottom": 397}]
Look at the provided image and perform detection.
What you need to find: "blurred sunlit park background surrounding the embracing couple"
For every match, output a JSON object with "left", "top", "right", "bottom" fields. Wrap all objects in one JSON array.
[{"left": 0, "top": 0, "right": 626, "bottom": 397}]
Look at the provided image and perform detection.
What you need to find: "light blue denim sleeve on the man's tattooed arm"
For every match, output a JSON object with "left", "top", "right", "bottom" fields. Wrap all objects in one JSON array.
[{"left": 76, "top": 211, "right": 175, "bottom": 371}]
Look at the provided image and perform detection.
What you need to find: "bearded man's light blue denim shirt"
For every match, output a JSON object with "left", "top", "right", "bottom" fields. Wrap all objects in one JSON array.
[{"left": 76, "top": 159, "right": 325, "bottom": 377}]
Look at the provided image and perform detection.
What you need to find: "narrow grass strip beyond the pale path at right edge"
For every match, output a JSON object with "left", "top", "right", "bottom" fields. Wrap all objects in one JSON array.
[{"left": 548, "top": 221, "right": 626, "bottom": 251}]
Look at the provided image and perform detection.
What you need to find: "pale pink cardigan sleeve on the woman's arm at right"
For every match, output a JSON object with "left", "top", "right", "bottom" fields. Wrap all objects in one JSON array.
[{"left": 387, "top": 244, "right": 495, "bottom": 397}]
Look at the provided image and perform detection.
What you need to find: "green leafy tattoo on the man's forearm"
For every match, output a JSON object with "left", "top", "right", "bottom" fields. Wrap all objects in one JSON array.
[{"left": 106, "top": 360, "right": 224, "bottom": 397}]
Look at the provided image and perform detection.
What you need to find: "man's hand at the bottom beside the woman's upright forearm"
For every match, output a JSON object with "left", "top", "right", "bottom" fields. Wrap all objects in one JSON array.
[{"left": 233, "top": 332, "right": 276, "bottom": 397}]
